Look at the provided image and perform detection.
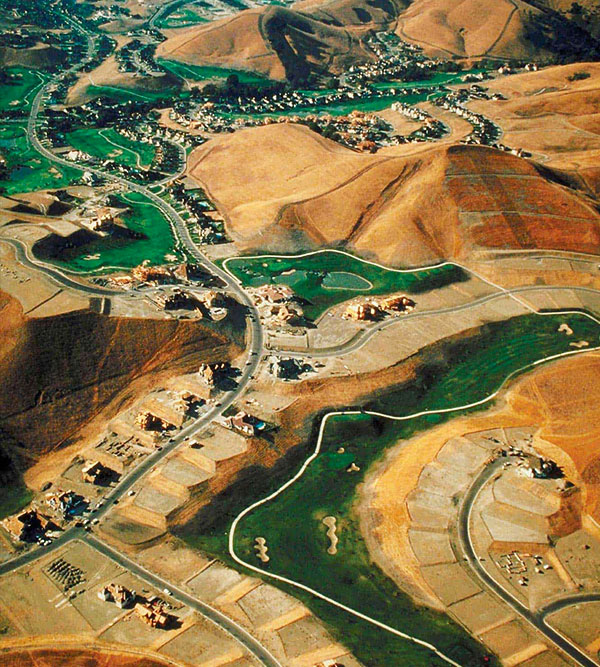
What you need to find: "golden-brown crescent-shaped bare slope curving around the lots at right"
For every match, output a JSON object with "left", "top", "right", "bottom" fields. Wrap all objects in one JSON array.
[{"left": 360, "top": 353, "right": 600, "bottom": 606}]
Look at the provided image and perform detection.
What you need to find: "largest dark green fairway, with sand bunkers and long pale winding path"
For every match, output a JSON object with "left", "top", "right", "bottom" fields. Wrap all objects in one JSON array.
[{"left": 183, "top": 314, "right": 600, "bottom": 667}]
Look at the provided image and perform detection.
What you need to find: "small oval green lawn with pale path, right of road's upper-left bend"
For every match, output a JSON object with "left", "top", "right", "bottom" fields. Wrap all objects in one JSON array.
[{"left": 67, "top": 128, "right": 156, "bottom": 167}]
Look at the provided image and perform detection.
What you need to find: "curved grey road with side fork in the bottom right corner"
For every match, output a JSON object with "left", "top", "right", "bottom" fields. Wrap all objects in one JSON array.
[{"left": 457, "top": 459, "right": 600, "bottom": 667}]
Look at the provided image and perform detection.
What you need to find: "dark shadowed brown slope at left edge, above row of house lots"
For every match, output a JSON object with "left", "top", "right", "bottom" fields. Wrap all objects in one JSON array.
[{"left": 0, "top": 293, "right": 244, "bottom": 455}]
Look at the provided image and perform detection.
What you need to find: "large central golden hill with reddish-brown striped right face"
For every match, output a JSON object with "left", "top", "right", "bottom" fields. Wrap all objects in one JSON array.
[{"left": 190, "top": 124, "right": 600, "bottom": 265}]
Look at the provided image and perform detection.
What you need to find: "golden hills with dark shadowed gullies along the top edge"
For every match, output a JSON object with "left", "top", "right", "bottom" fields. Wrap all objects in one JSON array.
[{"left": 157, "top": 0, "right": 600, "bottom": 83}]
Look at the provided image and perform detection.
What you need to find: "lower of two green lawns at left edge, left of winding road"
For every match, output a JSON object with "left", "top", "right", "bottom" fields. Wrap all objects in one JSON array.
[{"left": 0, "top": 124, "right": 81, "bottom": 195}]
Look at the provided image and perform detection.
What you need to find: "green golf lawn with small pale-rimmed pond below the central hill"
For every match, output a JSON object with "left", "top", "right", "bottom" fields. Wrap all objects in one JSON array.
[{"left": 223, "top": 250, "right": 467, "bottom": 319}]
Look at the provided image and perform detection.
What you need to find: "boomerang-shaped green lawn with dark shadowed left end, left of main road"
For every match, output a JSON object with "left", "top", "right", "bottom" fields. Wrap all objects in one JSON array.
[{"left": 41, "top": 192, "right": 182, "bottom": 273}]
